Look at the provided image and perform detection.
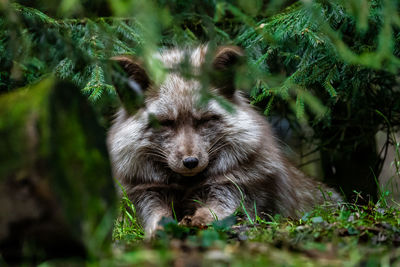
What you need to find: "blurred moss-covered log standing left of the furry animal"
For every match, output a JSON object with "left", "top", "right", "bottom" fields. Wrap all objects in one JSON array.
[{"left": 0, "top": 78, "right": 116, "bottom": 262}]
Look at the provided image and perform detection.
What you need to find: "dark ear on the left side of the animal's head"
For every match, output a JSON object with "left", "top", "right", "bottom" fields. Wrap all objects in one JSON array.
[{"left": 111, "top": 56, "right": 150, "bottom": 113}]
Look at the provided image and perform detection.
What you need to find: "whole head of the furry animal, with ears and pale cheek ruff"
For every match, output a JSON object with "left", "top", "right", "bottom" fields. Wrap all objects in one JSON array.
[{"left": 109, "top": 47, "right": 259, "bottom": 180}]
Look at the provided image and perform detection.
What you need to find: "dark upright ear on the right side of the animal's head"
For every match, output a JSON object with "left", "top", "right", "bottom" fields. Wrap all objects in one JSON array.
[{"left": 212, "top": 46, "right": 245, "bottom": 98}]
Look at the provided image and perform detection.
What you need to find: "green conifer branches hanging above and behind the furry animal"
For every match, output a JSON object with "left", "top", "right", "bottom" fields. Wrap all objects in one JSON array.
[{"left": 0, "top": 0, "right": 400, "bottom": 200}]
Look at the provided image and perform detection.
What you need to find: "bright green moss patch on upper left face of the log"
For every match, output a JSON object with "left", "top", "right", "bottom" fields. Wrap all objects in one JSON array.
[{"left": 0, "top": 79, "right": 54, "bottom": 182}]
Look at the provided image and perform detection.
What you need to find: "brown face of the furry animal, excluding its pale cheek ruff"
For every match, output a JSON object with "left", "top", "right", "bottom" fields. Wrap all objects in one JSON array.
[{"left": 146, "top": 75, "right": 229, "bottom": 176}]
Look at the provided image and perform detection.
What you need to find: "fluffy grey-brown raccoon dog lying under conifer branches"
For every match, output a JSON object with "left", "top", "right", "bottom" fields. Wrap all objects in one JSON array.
[{"left": 108, "top": 46, "right": 340, "bottom": 236}]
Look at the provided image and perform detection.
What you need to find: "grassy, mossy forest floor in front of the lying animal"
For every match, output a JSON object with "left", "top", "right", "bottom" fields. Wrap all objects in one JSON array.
[{"left": 105, "top": 195, "right": 400, "bottom": 266}]
